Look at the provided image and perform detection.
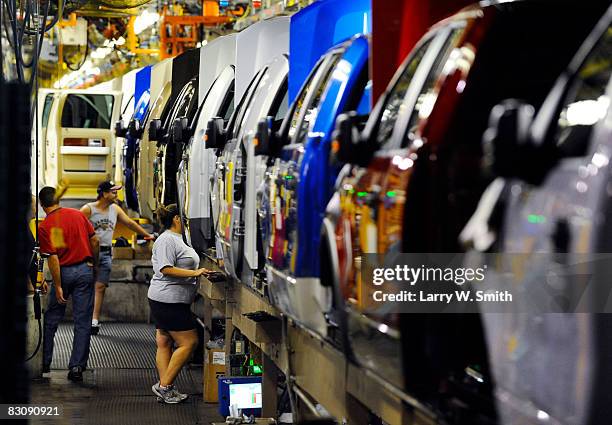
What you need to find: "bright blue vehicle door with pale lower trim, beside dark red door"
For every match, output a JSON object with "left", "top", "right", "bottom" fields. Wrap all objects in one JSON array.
[{"left": 260, "top": 36, "right": 369, "bottom": 334}]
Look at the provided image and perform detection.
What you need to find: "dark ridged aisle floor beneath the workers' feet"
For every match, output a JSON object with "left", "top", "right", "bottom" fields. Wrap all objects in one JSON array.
[{"left": 31, "top": 323, "right": 222, "bottom": 425}]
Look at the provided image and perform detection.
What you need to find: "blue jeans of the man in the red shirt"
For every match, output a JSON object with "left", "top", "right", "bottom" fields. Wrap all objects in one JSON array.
[{"left": 43, "top": 263, "right": 94, "bottom": 369}]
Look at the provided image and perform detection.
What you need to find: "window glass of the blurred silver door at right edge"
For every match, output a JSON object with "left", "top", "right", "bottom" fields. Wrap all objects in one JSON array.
[{"left": 555, "top": 26, "right": 612, "bottom": 157}]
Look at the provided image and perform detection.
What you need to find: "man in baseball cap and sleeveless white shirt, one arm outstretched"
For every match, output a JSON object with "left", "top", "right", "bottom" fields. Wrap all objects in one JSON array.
[{"left": 81, "top": 180, "right": 153, "bottom": 335}]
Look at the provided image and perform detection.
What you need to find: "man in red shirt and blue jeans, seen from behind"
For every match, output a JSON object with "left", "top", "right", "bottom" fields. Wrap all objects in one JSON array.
[{"left": 38, "top": 187, "right": 99, "bottom": 381}]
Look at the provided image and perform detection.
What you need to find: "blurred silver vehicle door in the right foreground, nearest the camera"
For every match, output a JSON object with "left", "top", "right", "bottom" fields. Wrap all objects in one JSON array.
[{"left": 463, "top": 8, "right": 612, "bottom": 424}]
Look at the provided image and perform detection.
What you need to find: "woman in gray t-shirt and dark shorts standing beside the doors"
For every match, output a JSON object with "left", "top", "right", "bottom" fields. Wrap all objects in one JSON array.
[{"left": 148, "top": 204, "right": 209, "bottom": 404}]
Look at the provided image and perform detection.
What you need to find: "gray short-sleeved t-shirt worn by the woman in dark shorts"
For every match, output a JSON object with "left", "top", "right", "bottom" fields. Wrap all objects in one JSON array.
[{"left": 148, "top": 230, "right": 200, "bottom": 304}]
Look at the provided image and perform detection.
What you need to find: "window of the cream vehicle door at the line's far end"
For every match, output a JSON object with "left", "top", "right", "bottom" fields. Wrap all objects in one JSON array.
[{"left": 62, "top": 94, "right": 115, "bottom": 129}]
